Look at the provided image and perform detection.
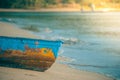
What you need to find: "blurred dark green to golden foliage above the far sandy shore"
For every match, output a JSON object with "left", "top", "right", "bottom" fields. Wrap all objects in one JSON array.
[{"left": 0, "top": 0, "right": 120, "bottom": 10}]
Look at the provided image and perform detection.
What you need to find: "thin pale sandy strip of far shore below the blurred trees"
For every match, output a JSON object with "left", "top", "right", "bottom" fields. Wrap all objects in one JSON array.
[{"left": 0, "top": 8, "right": 120, "bottom": 12}]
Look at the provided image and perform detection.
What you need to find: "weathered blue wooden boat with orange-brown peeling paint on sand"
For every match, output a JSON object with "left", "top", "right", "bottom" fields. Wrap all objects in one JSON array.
[{"left": 0, "top": 36, "right": 62, "bottom": 71}]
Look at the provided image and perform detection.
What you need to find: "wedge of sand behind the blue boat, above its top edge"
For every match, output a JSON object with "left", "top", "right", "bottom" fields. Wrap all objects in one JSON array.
[{"left": 0, "top": 22, "right": 39, "bottom": 38}]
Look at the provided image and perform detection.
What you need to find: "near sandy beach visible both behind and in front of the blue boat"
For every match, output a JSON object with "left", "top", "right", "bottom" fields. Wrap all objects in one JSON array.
[{"left": 0, "top": 22, "right": 113, "bottom": 80}]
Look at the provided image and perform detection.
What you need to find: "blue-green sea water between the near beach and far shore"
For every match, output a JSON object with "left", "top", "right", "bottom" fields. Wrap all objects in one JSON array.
[{"left": 0, "top": 12, "right": 120, "bottom": 80}]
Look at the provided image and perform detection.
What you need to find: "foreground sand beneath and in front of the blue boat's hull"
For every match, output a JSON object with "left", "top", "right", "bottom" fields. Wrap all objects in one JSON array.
[{"left": 0, "top": 63, "right": 112, "bottom": 80}]
